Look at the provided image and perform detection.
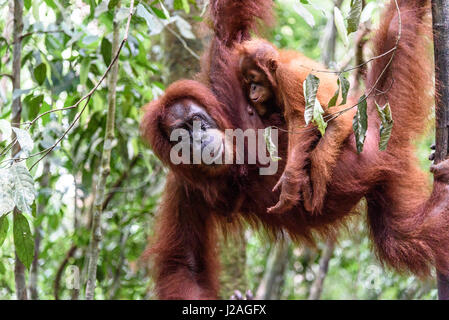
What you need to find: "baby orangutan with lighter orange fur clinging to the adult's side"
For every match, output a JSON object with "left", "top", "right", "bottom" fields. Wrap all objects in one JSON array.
[{"left": 237, "top": 39, "right": 353, "bottom": 213}]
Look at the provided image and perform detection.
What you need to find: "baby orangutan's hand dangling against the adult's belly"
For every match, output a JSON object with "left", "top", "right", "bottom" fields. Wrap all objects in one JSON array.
[{"left": 267, "top": 171, "right": 307, "bottom": 213}]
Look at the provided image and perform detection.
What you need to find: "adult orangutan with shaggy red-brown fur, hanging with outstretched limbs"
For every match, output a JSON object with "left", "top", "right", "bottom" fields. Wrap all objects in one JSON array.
[{"left": 141, "top": 0, "right": 449, "bottom": 299}]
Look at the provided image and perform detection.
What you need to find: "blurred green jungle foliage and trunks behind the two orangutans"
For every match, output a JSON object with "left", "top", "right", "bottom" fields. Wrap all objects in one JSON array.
[{"left": 0, "top": 0, "right": 437, "bottom": 299}]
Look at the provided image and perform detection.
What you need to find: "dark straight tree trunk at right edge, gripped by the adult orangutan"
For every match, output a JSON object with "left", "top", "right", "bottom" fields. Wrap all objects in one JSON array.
[{"left": 432, "top": 0, "right": 449, "bottom": 300}]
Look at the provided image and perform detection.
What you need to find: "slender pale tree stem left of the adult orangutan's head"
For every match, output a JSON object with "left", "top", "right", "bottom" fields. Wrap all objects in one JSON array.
[{"left": 86, "top": 2, "right": 125, "bottom": 300}]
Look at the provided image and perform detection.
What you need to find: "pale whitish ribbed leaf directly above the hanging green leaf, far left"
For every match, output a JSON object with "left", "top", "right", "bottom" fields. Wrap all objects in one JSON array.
[{"left": 9, "top": 164, "right": 35, "bottom": 213}]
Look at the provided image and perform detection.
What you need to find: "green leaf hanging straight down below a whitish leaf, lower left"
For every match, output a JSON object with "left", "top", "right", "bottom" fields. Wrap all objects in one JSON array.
[{"left": 13, "top": 213, "right": 34, "bottom": 269}]
